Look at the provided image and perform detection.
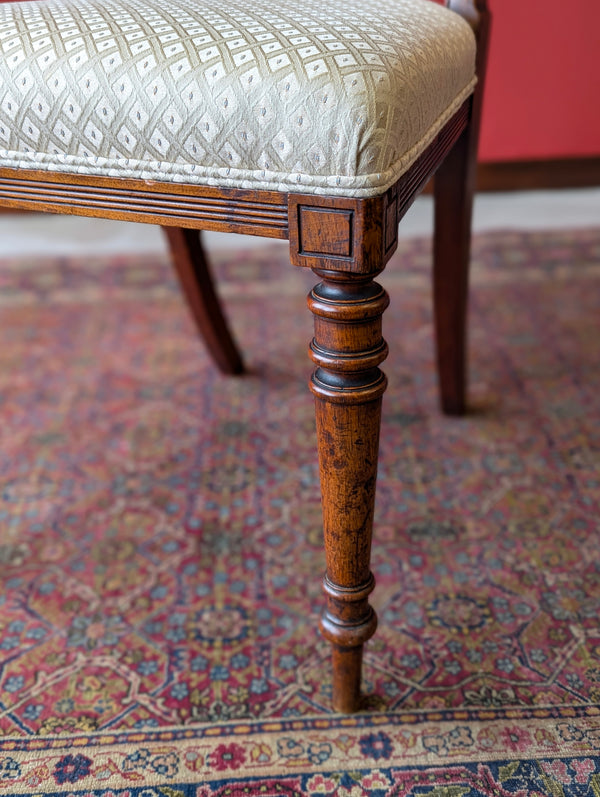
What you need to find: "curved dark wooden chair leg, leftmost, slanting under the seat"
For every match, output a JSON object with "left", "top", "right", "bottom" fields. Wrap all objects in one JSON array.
[{"left": 163, "top": 227, "right": 244, "bottom": 374}]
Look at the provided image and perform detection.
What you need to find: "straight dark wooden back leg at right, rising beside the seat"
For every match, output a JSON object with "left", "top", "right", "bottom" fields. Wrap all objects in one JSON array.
[{"left": 433, "top": 0, "right": 489, "bottom": 415}]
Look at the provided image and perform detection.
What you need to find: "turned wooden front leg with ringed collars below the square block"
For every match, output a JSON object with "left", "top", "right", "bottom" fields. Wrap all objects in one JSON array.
[{"left": 308, "top": 269, "right": 389, "bottom": 712}]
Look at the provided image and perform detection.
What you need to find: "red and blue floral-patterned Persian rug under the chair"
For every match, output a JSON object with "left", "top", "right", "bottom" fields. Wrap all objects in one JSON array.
[{"left": 0, "top": 224, "right": 600, "bottom": 797}]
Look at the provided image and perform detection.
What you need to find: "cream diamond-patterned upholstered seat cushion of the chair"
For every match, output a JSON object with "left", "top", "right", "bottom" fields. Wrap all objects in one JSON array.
[{"left": 0, "top": 0, "right": 475, "bottom": 197}]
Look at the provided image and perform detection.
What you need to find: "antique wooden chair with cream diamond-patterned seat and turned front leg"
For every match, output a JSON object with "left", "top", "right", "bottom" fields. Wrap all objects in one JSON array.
[{"left": 0, "top": 0, "right": 488, "bottom": 711}]
